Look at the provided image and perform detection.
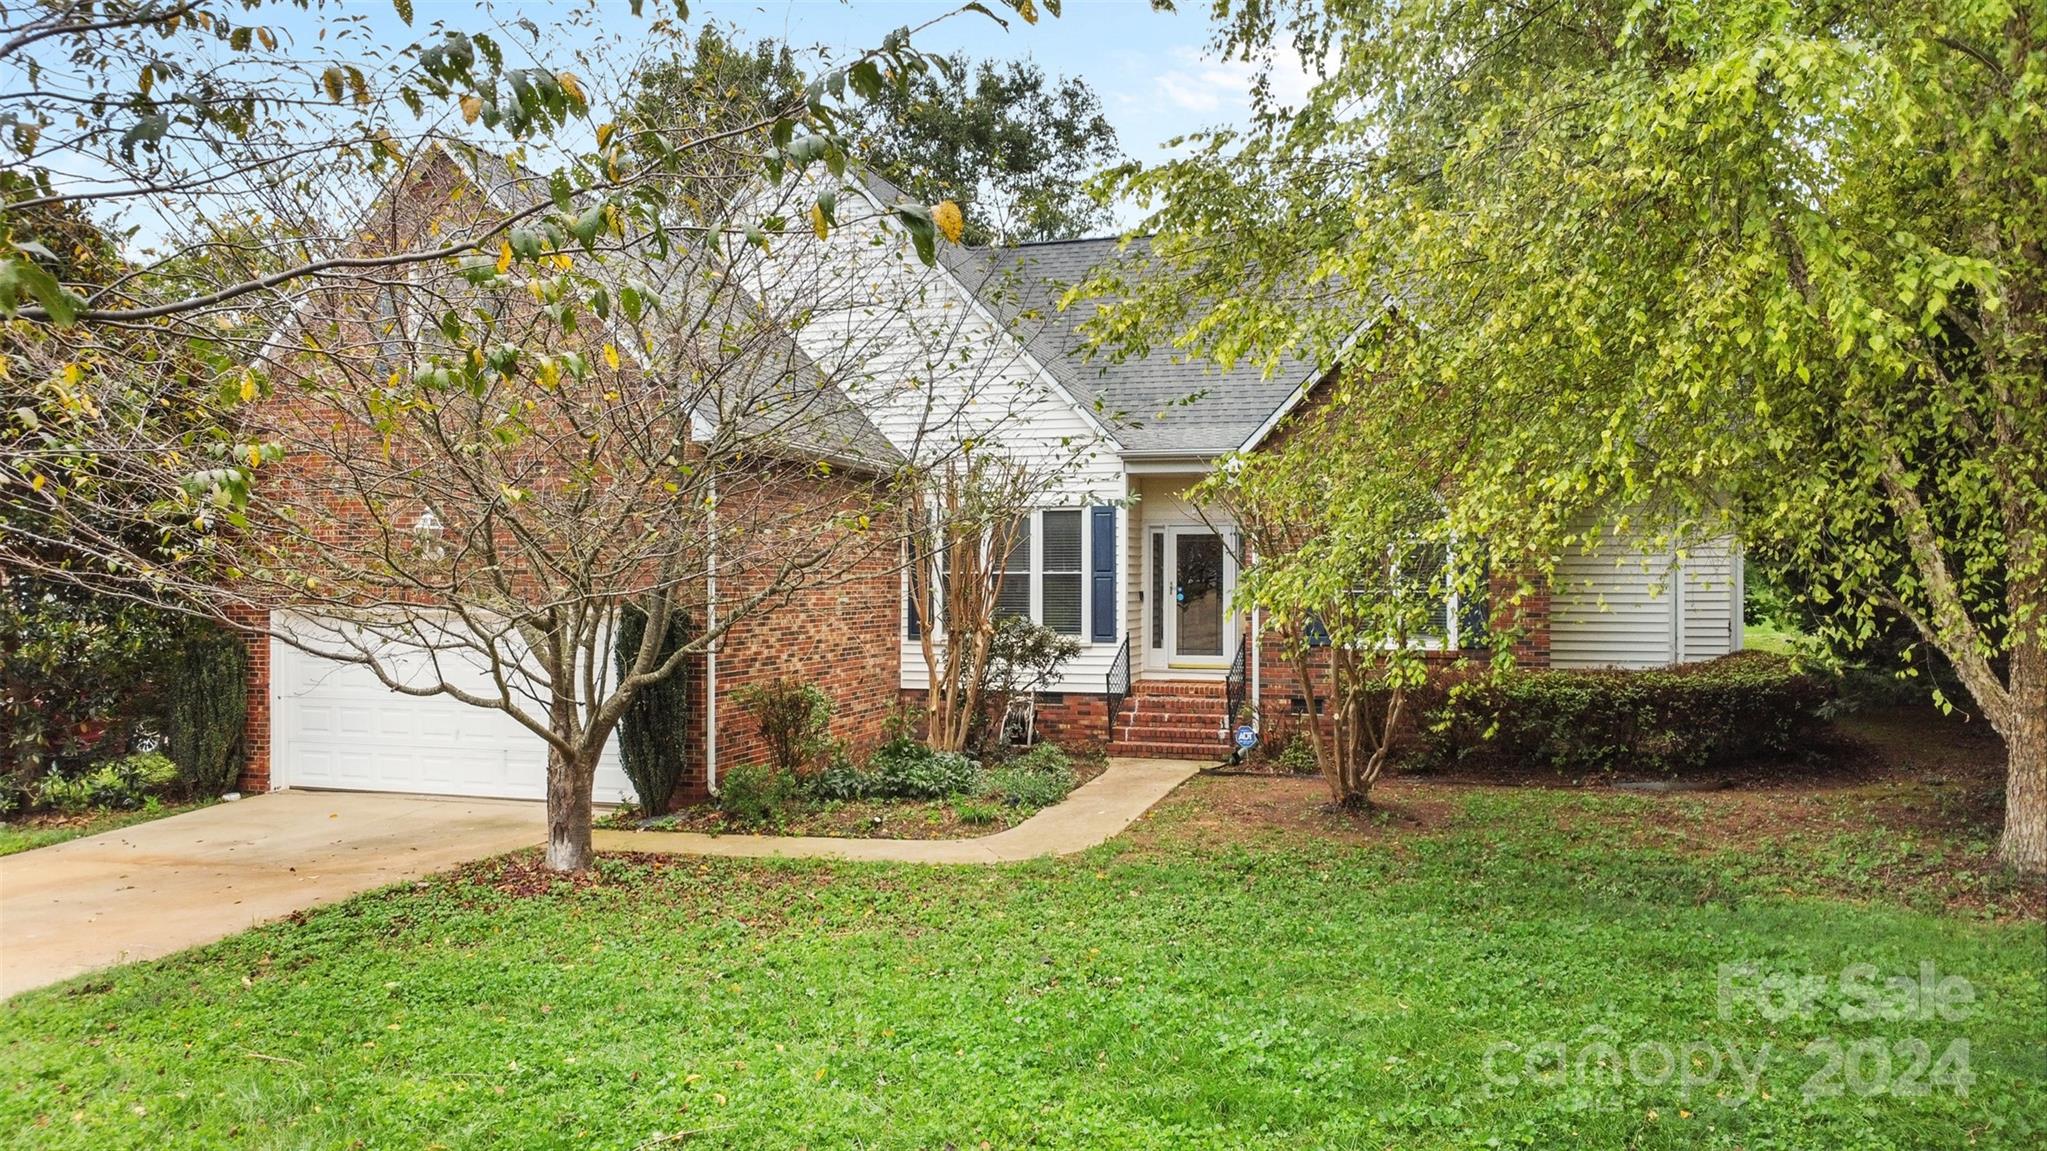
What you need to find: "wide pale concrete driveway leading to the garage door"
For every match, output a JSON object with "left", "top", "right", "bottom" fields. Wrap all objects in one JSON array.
[{"left": 0, "top": 791, "right": 547, "bottom": 997}]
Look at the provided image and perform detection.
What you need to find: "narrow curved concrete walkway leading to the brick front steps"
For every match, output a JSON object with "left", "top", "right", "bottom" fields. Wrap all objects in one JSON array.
[{"left": 596, "top": 760, "right": 1208, "bottom": 864}]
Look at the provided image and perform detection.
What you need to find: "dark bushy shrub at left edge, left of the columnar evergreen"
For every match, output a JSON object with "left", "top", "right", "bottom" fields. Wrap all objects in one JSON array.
[{"left": 0, "top": 573, "right": 180, "bottom": 780}]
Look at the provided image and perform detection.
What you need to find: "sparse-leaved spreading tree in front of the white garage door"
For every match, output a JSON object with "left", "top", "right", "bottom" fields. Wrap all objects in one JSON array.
[{"left": 0, "top": 6, "right": 1072, "bottom": 868}]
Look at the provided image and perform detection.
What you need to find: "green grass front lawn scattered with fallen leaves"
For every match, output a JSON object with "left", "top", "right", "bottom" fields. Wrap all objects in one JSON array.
[{"left": 0, "top": 737, "right": 2047, "bottom": 1149}]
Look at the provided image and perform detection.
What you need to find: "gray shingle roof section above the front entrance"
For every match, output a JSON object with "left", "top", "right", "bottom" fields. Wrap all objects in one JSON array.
[{"left": 940, "top": 238, "right": 1312, "bottom": 455}]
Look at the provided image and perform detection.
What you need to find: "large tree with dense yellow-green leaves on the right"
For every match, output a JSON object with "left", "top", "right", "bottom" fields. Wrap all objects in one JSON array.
[{"left": 1097, "top": 0, "right": 2047, "bottom": 872}]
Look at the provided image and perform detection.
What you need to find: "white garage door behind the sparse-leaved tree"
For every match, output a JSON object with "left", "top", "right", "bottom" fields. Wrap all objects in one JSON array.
[{"left": 270, "top": 625, "right": 633, "bottom": 803}]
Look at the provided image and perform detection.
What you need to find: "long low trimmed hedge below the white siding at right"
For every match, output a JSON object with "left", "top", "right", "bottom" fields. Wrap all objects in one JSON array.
[{"left": 1414, "top": 651, "right": 1830, "bottom": 774}]
